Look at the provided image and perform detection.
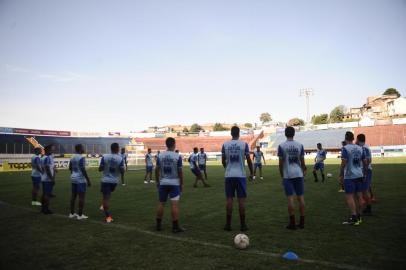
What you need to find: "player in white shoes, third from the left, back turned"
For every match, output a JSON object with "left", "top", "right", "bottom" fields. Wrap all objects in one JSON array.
[{"left": 69, "top": 144, "right": 91, "bottom": 220}]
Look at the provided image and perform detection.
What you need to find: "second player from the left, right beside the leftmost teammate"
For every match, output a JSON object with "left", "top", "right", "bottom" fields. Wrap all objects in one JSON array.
[{"left": 41, "top": 144, "right": 55, "bottom": 215}]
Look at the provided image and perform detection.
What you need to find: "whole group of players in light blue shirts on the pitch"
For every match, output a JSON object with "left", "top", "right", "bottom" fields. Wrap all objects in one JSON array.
[{"left": 31, "top": 126, "right": 372, "bottom": 233}]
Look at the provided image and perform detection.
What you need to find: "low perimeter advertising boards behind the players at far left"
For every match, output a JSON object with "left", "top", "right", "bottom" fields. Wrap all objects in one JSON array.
[{"left": 0, "top": 158, "right": 100, "bottom": 172}]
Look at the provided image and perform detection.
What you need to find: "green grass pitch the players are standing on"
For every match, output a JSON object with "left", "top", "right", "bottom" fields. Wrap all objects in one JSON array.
[{"left": 0, "top": 158, "right": 406, "bottom": 270}]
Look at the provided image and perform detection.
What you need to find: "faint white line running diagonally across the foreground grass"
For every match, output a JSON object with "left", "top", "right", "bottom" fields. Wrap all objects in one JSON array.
[{"left": 0, "top": 201, "right": 374, "bottom": 270}]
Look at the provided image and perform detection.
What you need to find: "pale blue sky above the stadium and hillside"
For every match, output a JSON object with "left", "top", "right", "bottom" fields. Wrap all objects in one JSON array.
[{"left": 0, "top": 0, "right": 406, "bottom": 131}]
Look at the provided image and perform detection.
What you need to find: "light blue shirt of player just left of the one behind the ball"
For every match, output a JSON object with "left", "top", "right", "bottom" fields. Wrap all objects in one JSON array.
[{"left": 156, "top": 151, "right": 182, "bottom": 186}]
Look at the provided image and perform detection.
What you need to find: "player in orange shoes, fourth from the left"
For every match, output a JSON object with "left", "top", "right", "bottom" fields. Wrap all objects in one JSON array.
[{"left": 99, "top": 143, "right": 124, "bottom": 223}]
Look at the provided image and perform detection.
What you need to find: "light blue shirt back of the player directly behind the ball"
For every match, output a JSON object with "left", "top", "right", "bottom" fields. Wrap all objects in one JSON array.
[{"left": 221, "top": 140, "right": 249, "bottom": 177}]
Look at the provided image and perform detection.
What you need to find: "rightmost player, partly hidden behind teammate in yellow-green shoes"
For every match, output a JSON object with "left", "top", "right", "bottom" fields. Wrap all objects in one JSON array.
[{"left": 356, "top": 134, "right": 372, "bottom": 215}]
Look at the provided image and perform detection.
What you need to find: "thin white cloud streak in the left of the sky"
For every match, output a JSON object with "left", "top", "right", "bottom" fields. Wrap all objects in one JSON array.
[{"left": 5, "top": 64, "right": 89, "bottom": 82}]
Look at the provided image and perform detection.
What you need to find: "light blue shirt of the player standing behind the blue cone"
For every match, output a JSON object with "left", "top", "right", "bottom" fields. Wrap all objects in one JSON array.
[{"left": 278, "top": 140, "right": 304, "bottom": 179}]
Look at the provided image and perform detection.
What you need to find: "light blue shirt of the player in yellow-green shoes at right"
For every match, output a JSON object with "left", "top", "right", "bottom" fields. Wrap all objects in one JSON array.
[{"left": 341, "top": 144, "right": 365, "bottom": 179}]
